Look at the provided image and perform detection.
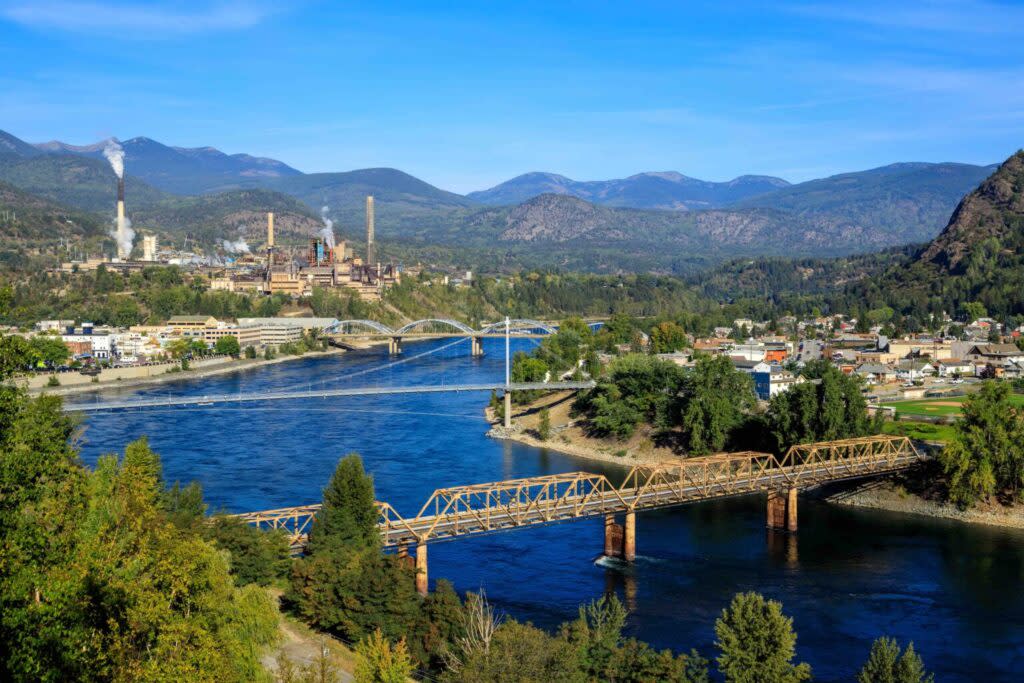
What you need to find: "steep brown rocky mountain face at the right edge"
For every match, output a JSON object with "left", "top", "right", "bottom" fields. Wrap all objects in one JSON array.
[{"left": 921, "top": 151, "right": 1024, "bottom": 272}]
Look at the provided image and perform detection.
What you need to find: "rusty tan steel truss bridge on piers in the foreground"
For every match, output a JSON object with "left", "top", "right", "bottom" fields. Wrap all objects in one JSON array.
[{"left": 233, "top": 436, "right": 927, "bottom": 557}]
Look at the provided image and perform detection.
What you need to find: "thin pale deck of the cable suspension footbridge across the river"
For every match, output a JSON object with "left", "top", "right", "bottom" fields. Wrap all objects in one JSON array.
[{"left": 63, "top": 381, "right": 594, "bottom": 413}]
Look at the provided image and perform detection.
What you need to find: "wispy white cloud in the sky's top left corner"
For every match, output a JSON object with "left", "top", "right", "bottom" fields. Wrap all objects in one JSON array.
[{"left": 0, "top": 0, "right": 271, "bottom": 40}]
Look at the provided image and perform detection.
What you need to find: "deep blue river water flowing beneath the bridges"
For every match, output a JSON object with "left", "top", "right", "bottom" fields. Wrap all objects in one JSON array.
[{"left": 69, "top": 340, "right": 1024, "bottom": 682}]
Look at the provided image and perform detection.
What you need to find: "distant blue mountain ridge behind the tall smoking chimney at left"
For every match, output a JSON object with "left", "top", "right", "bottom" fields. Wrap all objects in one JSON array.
[{"left": 34, "top": 137, "right": 300, "bottom": 195}]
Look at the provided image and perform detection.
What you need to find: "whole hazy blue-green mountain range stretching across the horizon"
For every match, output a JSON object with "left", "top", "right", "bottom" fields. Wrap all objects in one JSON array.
[{"left": 0, "top": 131, "right": 995, "bottom": 271}]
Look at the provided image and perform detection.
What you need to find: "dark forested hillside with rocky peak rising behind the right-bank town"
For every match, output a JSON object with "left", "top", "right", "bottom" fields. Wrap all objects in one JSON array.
[{"left": 691, "top": 152, "right": 1024, "bottom": 323}]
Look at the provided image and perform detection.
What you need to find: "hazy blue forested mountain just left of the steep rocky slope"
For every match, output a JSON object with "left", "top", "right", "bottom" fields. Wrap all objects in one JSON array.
[{"left": 733, "top": 163, "right": 995, "bottom": 244}]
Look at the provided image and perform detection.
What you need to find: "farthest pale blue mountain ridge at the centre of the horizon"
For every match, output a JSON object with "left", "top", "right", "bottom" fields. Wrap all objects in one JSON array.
[{"left": 467, "top": 171, "right": 790, "bottom": 211}]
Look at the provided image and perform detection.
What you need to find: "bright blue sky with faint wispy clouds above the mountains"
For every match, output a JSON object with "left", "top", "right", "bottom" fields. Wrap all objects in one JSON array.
[{"left": 0, "top": 0, "right": 1024, "bottom": 191}]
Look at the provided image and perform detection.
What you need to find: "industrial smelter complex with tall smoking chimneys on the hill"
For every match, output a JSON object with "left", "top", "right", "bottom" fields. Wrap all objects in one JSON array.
[{"left": 59, "top": 149, "right": 401, "bottom": 301}]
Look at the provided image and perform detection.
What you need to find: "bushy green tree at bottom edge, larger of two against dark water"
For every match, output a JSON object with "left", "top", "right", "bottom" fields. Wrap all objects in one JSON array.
[{"left": 715, "top": 593, "right": 811, "bottom": 683}]
